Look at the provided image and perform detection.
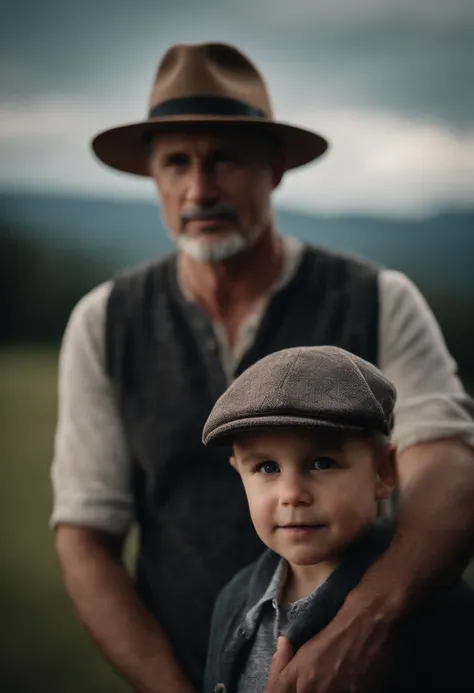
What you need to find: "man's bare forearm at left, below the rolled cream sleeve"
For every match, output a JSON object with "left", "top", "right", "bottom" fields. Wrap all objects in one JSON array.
[{"left": 56, "top": 526, "right": 193, "bottom": 693}]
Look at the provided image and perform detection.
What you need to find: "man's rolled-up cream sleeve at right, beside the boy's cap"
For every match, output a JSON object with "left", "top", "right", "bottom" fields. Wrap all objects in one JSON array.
[{"left": 379, "top": 270, "right": 474, "bottom": 451}]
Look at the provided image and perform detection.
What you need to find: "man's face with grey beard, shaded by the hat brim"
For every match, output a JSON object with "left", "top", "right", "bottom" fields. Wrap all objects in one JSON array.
[{"left": 150, "top": 128, "right": 282, "bottom": 262}]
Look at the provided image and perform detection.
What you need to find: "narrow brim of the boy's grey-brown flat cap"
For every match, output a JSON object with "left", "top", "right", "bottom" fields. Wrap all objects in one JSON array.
[{"left": 202, "top": 416, "right": 366, "bottom": 446}]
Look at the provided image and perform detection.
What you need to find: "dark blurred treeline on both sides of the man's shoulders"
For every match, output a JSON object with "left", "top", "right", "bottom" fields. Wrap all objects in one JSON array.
[{"left": 0, "top": 225, "right": 474, "bottom": 389}]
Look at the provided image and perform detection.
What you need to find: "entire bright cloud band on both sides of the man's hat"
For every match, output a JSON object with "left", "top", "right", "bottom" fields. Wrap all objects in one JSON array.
[{"left": 0, "top": 99, "right": 474, "bottom": 218}]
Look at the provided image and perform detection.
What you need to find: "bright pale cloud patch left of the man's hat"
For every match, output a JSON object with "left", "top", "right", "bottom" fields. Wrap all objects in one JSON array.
[{"left": 0, "top": 98, "right": 156, "bottom": 197}]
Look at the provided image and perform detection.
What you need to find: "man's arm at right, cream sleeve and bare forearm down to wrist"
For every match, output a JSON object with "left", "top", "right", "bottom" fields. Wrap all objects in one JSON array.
[{"left": 352, "top": 272, "right": 474, "bottom": 604}]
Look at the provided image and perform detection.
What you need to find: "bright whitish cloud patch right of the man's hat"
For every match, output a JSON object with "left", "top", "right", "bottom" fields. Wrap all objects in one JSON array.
[{"left": 277, "top": 111, "right": 474, "bottom": 217}]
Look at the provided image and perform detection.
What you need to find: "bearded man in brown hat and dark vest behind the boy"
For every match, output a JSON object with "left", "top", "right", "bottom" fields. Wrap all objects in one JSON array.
[{"left": 52, "top": 44, "right": 474, "bottom": 693}]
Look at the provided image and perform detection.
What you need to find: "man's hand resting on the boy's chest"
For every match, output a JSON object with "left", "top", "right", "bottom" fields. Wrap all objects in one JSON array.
[{"left": 265, "top": 592, "right": 391, "bottom": 693}]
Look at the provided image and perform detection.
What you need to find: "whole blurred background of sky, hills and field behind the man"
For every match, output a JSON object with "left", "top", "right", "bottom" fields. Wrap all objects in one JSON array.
[{"left": 0, "top": 0, "right": 474, "bottom": 693}]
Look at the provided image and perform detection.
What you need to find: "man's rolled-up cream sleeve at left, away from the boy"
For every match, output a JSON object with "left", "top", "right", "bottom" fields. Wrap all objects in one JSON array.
[{"left": 50, "top": 282, "right": 133, "bottom": 534}]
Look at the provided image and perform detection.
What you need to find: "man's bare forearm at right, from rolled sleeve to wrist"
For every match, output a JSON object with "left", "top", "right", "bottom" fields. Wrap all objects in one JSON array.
[{"left": 353, "top": 440, "right": 474, "bottom": 618}]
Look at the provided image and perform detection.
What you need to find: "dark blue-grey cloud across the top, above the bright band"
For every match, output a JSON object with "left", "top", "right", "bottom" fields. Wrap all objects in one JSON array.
[{"left": 0, "top": 0, "right": 474, "bottom": 129}]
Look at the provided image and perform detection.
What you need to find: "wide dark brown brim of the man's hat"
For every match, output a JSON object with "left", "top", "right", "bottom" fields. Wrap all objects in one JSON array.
[{"left": 92, "top": 115, "right": 329, "bottom": 176}]
